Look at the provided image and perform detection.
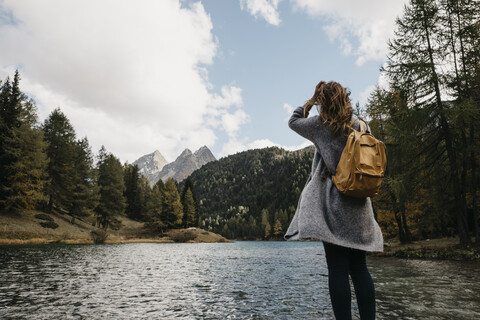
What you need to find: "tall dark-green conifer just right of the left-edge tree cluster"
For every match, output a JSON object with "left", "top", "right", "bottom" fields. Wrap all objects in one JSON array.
[{"left": 43, "top": 108, "right": 76, "bottom": 211}]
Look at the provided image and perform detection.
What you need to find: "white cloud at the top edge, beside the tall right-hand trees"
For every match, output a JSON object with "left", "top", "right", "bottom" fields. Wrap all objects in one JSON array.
[{"left": 293, "top": 0, "right": 407, "bottom": 65}]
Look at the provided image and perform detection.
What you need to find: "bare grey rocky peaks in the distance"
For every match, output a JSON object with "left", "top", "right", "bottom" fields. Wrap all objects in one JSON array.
[{"left": 133, "top": 146, "right": 217, "bottom": 185}]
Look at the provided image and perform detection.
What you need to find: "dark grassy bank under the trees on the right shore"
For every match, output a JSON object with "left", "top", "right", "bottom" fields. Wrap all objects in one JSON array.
[{"left": 375, "top": 238, "right": 480, "bottom": 261}]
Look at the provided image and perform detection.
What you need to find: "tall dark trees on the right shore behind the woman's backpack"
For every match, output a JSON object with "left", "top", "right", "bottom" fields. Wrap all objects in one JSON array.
[{"left": 366, "top": 0, "right": 480, "bottom": 245}]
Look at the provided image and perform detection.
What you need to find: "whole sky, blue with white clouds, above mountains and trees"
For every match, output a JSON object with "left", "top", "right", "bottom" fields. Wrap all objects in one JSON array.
[{"left": 0, "top": 0, "right": 406, "bottom": 163}]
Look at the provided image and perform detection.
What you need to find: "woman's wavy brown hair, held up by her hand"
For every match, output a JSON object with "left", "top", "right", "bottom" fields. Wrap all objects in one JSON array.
[{"left": 303, "top": 81, "right": 353, "bottom": 135}]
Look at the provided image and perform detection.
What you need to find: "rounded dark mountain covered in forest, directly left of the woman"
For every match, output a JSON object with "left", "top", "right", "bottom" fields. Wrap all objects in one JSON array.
[{"left": 184, "top": 147, "right": 315, "bottom": 239}]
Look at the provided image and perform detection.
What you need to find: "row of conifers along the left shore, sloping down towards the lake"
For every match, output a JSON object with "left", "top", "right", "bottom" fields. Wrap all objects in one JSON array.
[{"left": 0, "top": 71, "right": 198, "bottom": 232}]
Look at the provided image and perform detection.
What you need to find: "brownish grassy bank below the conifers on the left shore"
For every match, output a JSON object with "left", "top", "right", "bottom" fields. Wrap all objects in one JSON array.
[{"left": 0, "top": 211, "right": 228, "bottom": 245}]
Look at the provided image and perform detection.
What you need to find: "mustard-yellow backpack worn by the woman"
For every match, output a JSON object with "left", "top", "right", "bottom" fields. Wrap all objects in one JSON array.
[{"left": 327, "top": 119, "right": 387, "bottom": 198}]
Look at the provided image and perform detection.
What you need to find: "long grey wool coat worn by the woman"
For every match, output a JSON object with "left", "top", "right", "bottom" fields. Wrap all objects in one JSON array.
[{"left": 285, "top": 107, "right": 383, "bottom": 251}]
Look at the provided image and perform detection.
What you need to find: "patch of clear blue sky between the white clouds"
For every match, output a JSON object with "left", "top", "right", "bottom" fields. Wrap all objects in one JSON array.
[{"left": 204, "top": 0, "right": 390, "bottom": 154}]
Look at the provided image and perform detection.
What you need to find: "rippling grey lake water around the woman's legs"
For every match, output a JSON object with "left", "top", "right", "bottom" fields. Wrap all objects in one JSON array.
[{"left": 0, "top": 242, "right": 480, "bottom": 320}]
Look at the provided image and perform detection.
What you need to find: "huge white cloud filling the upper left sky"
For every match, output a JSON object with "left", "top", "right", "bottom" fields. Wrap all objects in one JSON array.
[{"left": 0, "top": 0, "right": 248, "bottom": 162}]
